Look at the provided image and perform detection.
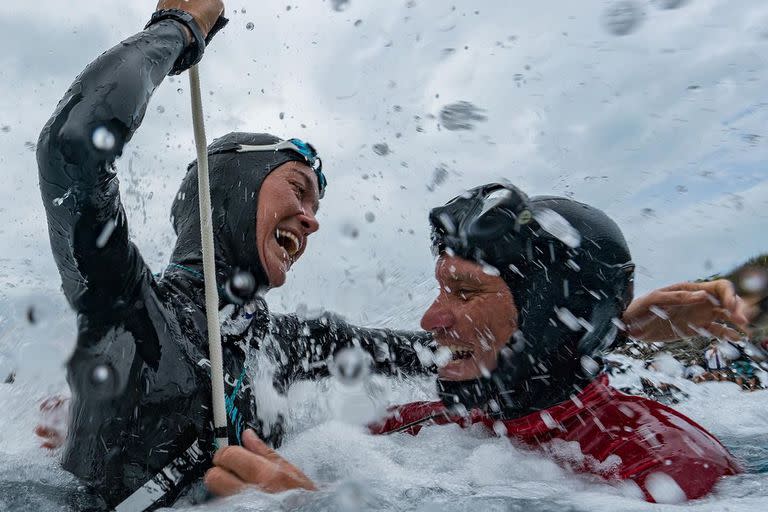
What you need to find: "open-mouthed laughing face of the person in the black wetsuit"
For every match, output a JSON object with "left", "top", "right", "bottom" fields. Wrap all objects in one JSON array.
[{"left": 256, "top": 162, "right": 320, "bottom": 288}]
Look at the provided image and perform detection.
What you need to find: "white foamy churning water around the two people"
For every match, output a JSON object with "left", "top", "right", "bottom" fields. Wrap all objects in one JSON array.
[{"left": 0, "top": 320, "right": 768, "bottom": 512}]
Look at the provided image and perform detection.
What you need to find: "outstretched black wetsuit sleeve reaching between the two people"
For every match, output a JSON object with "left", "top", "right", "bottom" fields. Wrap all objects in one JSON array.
[{"left": 272, "top": 313, "right": 436, "bottom": 381}]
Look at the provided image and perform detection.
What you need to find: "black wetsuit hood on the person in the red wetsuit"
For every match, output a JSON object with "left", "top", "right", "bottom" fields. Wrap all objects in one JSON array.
[{"left": 430, "top": 183, "right": 634, "bottom": 418}]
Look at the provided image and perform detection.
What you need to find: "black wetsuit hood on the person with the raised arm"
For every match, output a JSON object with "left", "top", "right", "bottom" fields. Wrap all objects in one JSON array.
[{"left": 171, "top": 132, "right": 305, "bottom": 289}]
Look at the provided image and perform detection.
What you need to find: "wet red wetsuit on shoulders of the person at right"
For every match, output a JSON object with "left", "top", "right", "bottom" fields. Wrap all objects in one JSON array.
[{"left": 370, "top": 374, "right": 741, "bottom": 501}]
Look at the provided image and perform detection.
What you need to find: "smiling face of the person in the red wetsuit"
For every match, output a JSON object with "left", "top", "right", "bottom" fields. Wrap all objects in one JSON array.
[{"left": 421, "top": 255, "right": 517, "bottom": 380}]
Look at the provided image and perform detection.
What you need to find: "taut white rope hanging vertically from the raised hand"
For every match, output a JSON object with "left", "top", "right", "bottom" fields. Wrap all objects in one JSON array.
[{"left": 189, "top": 65, "right": 229, "bottom": 448}]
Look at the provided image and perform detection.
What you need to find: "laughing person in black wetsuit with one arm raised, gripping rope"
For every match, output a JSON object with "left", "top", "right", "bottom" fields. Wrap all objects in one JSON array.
[{"left": 37, "top": 0, "right": 428, "bottom": 510}]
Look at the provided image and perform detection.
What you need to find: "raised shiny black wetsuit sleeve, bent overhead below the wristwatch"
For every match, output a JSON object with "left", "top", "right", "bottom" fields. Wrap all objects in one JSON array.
[{"left": 37, "top": 21, "right": 190, "bottom": 312}]
